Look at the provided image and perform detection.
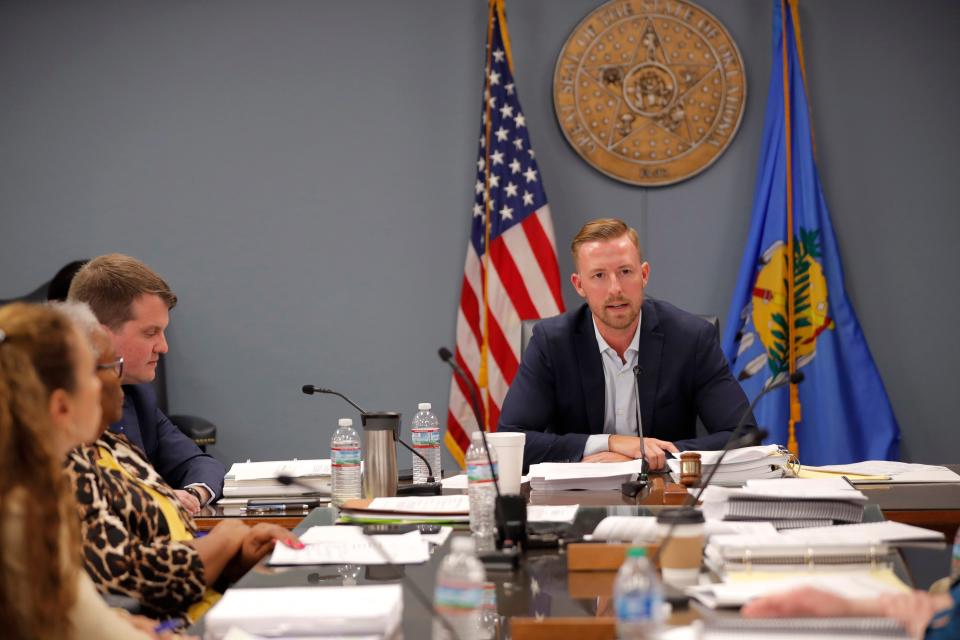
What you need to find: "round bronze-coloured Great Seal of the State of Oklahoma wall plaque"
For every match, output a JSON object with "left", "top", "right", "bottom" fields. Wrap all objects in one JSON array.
[{"left": 553, "top": 0, "right": 747, "bottom": 186}]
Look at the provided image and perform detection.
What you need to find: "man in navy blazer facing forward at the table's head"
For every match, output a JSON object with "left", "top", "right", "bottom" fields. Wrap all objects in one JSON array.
[{"left": 498, "top": 218, "right": 756, "bottom": 470}]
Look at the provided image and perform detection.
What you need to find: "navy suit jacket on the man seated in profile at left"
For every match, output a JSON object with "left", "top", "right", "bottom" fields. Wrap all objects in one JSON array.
[{"left": 110, "top": 384, "right": 227, "bottom": 499}]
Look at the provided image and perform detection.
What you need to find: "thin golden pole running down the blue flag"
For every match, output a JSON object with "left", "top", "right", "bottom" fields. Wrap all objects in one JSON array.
[{"left": 780, "top": 0, "right": 801, "bottom": 456}]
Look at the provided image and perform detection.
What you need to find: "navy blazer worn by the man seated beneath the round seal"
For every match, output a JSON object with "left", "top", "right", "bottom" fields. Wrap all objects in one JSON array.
[{"left": 498, "top": 297, "right": 756, "bottom": 468}]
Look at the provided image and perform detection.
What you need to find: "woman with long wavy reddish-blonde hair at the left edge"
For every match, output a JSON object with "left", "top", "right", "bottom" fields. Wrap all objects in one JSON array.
[{"left": 0, "top": 303, "right": 159, "bottom": 639}]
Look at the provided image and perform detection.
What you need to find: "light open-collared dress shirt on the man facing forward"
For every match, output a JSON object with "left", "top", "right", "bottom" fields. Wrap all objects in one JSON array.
[{"left": 583, "top": 312, "right": 643, "bottom": 457}]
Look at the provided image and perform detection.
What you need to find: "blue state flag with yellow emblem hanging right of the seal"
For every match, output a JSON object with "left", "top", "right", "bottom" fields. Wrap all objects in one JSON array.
[{"left": 723, "top": 0, "right": 900, "bottom": 465}]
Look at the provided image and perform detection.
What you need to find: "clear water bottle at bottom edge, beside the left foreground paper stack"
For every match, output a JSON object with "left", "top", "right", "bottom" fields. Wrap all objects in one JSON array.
[{"left": 433, "top": 536, "right": 487, "bottom": 640}]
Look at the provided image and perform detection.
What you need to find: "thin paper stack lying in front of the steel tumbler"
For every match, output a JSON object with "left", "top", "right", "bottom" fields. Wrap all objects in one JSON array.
[{"left": 340, "top": 494, "right": 470, "bottom": 524}]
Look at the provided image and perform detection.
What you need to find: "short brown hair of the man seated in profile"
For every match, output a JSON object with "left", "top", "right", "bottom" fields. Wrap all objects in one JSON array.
[{"left": 67, "top": 253, "right": 177, "bottom": 331}]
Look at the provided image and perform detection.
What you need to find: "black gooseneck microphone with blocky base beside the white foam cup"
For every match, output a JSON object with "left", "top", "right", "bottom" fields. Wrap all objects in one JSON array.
[{"left": 437, "top": 347, "right": 527, "bottom": 569}]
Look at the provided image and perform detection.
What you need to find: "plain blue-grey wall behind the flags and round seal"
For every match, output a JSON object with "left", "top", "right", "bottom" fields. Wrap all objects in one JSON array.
[{"left": 0, "top": 0, "right": 960, "bottom": 466}]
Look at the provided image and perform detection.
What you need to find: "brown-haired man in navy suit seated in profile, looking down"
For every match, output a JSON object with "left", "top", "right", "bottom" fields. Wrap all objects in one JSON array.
[{"left": 69, "top": 253, "right": 226, "bottom": 513}]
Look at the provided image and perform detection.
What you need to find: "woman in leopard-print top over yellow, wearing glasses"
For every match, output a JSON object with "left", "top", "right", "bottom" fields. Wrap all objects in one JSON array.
[{"left": 66, "top": 308, "right": 302, "bottom": 621}]
